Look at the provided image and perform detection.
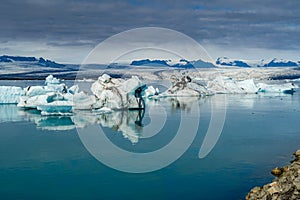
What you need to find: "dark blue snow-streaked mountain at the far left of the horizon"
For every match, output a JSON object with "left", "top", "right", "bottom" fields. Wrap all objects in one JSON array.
[{"left": 0, "top": 55, "right": 65, "bottom": 68}]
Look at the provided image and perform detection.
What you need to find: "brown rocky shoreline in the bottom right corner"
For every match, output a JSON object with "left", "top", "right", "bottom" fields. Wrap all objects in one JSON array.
[{"left": 246, "top": 149, "right": 300, "bottom": 200}]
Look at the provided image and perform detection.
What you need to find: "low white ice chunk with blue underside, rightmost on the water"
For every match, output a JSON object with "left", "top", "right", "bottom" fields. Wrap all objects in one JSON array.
[{"left": 257, "top": 83, "right": 299, "bottom": 94}]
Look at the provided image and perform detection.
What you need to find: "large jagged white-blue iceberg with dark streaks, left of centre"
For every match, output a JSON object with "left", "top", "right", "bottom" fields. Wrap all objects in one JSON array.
[{"left": 17, "top": 74, "right": 151, "bottom": 115}]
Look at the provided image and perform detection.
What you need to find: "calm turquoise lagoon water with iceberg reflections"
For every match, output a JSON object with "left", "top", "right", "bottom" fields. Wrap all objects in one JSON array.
[{"left": 0, "top": 80, "right": 300, "bottom": 199}]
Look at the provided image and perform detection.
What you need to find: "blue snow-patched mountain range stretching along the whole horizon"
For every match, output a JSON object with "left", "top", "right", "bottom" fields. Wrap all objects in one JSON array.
[{"left": 0, "top": 55, "right": 300, "bottom": 69}]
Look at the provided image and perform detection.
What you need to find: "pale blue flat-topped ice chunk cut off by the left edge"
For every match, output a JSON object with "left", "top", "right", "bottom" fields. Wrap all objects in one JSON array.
[{"left": 0, "top": 86, "right": 25, "bottom": 104}]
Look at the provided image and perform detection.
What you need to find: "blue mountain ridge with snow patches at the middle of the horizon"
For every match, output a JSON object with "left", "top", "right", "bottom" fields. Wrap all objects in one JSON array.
[{"left": 130, "top": 59, "right": 215, "bottom": 69}]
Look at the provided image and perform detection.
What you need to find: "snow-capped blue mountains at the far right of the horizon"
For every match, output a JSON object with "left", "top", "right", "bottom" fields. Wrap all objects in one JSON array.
[{"left": 216, "top": 57, "right": 300, "bottom": 67}]
